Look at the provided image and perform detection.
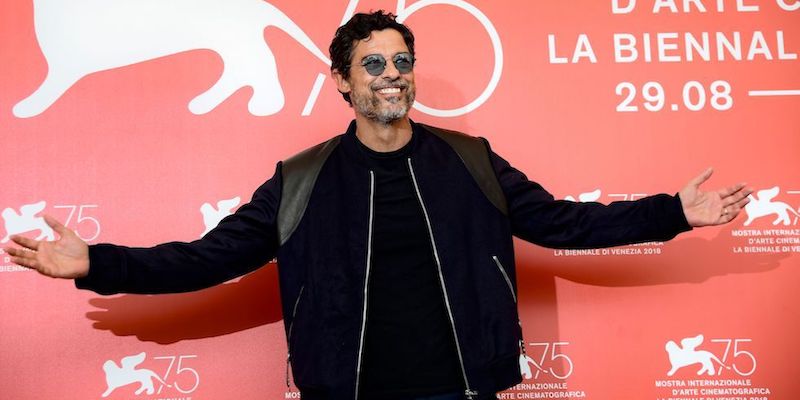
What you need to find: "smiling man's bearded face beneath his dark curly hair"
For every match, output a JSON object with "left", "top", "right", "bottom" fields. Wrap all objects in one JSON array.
[{"left": 335, "top": 29, "right": 416, "bottom": 125}]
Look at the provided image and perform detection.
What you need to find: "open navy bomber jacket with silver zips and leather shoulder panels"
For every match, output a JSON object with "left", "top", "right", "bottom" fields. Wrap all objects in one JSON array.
[{"left": 76, "top": 123, "right": 691, "bottom": 400}]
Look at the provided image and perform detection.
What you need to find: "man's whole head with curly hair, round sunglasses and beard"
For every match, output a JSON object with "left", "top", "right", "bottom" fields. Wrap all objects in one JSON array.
[{"left": 330, "top": 11, "right": 415, "bottom": 124}]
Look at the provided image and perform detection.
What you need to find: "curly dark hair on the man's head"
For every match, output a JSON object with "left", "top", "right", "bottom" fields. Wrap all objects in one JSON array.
[{"left": 329, "top": 10, "right": 414, "bottom": 104}]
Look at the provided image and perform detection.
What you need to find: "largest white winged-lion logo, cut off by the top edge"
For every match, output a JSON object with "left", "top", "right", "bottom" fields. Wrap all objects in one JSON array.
[{"left": 13, "top": 0, "right": 330, "bottom": 118}]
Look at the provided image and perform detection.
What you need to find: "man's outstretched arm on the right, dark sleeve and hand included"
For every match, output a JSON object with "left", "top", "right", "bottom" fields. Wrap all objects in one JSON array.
[{"left": 490, "top": 142, "right": 752, "bottom": 248}]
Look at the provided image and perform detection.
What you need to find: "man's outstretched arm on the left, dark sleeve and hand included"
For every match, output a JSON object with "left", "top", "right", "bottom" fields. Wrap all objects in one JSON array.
[{"left": 6, "top": 167, "right": 281, "bottom": 294}]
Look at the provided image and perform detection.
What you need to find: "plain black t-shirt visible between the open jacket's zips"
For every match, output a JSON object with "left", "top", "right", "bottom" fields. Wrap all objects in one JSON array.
[{"left": 360, "top": 136, "right": 464, "bottom": 400}]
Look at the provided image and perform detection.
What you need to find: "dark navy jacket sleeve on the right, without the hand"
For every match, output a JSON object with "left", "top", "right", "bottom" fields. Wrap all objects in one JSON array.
[{"left": 489, "top": 144, "right": 692, "bottom": 249}]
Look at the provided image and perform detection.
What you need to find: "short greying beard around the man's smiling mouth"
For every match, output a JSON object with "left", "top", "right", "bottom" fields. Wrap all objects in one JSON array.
[{"left": 350, "top": 79, "right": 416, "bottom": 125}]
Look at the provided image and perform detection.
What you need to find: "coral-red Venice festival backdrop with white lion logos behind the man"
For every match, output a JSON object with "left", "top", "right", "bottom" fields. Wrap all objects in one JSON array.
[{"left": 0, "top": 0, "right": 800, "bottom": 400}]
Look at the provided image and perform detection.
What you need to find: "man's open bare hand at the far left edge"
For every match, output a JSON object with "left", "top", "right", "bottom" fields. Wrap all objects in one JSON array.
[{"left": 5, "top": 215, "right": 89, "bottom": 279}]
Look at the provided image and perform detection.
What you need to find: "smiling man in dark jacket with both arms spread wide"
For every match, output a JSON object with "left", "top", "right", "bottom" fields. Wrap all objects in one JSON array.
[{"left": 7, "top": 12, "right": 751, "bottom": 399}]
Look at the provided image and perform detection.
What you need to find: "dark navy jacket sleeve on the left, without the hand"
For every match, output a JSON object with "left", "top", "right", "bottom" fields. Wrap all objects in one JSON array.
[{"left": 75, "top": 163, "right": 281, "bottom": 294}]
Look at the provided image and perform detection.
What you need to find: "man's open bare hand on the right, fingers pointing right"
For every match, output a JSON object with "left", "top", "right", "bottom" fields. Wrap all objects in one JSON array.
[{"left": 680, "top": 168, "right": 753, "bottom": 227}]
